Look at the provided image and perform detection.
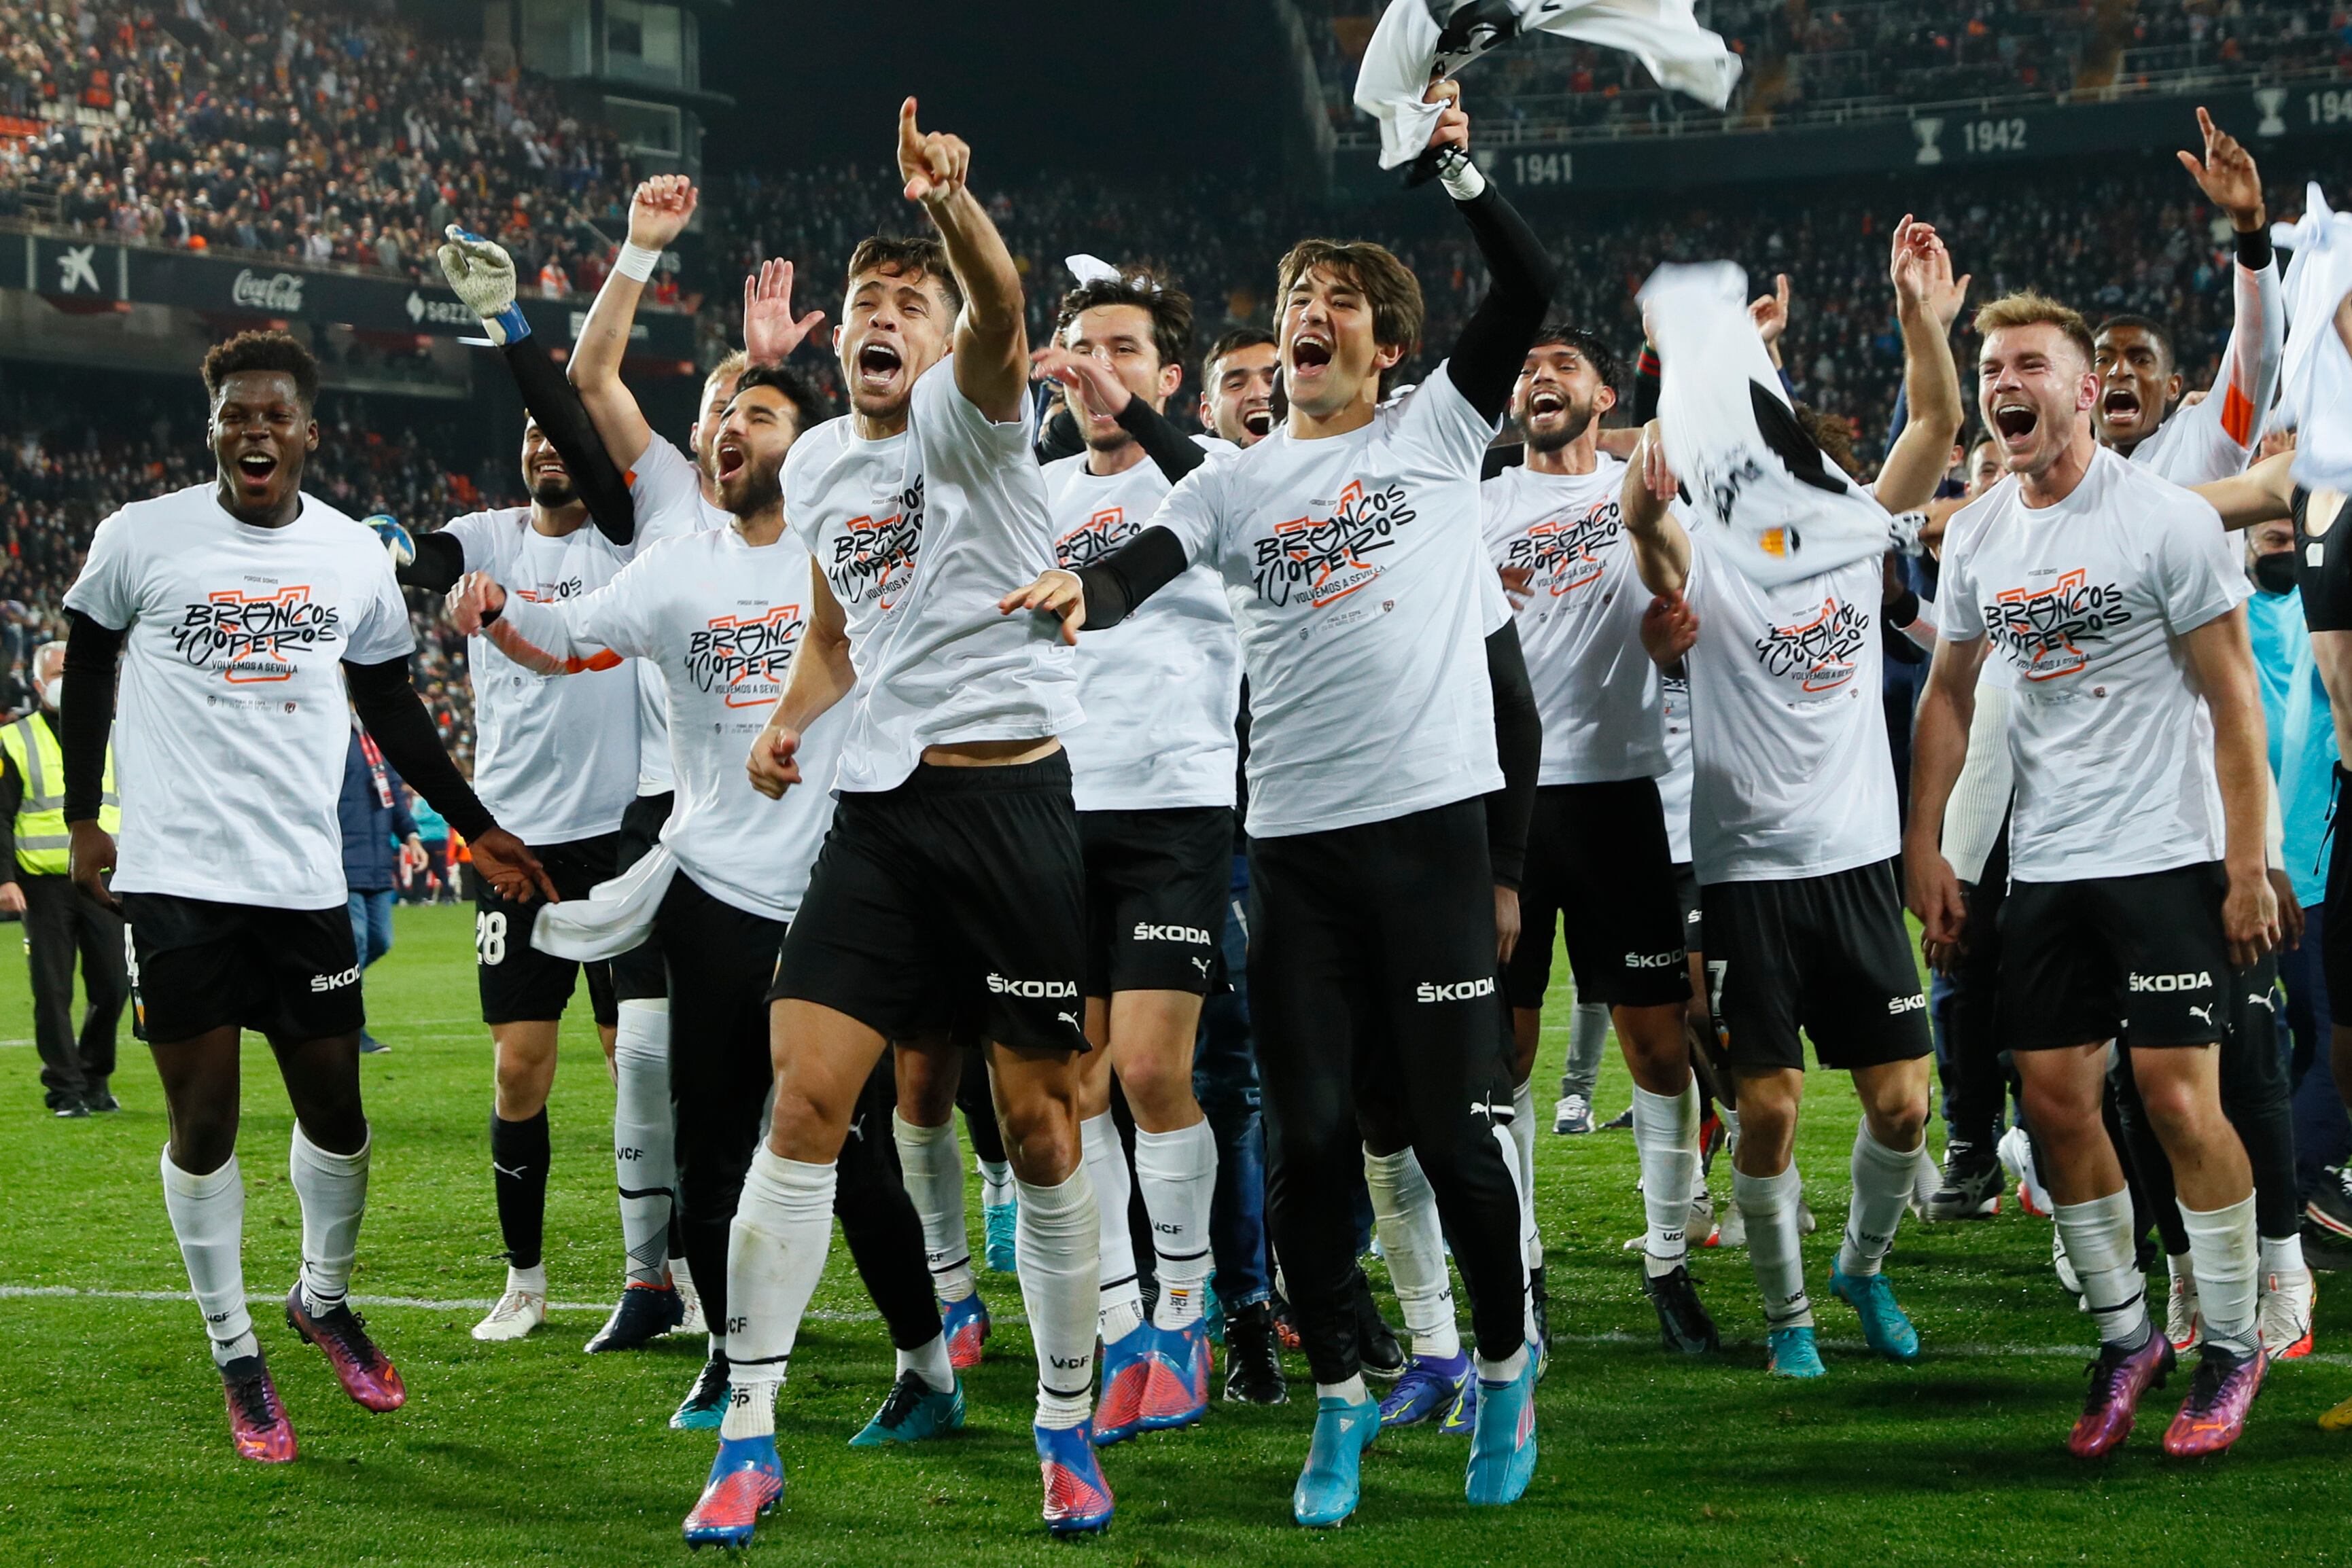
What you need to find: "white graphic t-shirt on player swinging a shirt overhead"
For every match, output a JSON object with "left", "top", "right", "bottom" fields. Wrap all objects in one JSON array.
[{"left": 1153, "top": 367, "right": 1503, "bottom": 839}]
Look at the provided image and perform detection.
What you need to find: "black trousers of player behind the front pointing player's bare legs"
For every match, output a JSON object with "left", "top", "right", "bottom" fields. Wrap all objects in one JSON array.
[{"left": 654, "top": 872, "right": 938, "bottom": 1349}]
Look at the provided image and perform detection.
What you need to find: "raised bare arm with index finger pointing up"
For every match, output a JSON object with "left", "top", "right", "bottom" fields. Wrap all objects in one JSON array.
[{"left": 898, "top": 99, "right": 1028, "bottom": 425}]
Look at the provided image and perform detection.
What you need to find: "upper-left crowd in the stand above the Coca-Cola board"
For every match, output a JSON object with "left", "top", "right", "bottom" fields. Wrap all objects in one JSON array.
[{"left": 0, "top": 0, "right": 635, "bottom": 294}]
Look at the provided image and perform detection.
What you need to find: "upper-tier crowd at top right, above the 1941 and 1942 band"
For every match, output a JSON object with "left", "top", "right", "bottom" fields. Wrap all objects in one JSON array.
[{"left": 1301, "top": 0, "right": 2352, "bottom": 127}]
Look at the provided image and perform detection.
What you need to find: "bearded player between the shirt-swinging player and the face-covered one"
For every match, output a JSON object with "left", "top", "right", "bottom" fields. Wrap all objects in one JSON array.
[{"left": 1479, "top": 327, "right": 1717, "bottom": 1354}]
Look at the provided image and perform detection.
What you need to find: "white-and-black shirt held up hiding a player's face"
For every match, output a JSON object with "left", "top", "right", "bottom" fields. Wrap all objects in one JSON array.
[{"left": 1639, "top": 261, "right": 1917, "bottom": 588}]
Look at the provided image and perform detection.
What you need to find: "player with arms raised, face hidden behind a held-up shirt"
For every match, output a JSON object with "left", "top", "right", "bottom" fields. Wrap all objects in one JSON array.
[{"left": 1621, "top": 219, "right": 1961, "bottom": 1378}]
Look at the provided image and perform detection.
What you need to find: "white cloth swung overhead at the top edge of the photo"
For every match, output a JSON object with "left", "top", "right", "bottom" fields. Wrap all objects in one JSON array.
[{"left": 1355, "top": 0, "right": 1740, "bottom": 169}]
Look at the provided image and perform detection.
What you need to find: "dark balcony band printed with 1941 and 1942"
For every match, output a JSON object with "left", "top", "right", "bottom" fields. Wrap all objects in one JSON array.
[{"left": 1333, "top": 61, "right": 2352, "bottom": 153}]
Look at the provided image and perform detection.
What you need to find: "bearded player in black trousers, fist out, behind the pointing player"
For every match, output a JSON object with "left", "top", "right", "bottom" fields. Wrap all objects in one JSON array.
[{"left": 444, "top": 355, "right": 964, "bottom": 1446}]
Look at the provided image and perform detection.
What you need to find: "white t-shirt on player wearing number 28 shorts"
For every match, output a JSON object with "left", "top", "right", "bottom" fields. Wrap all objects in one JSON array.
[{"left": 442, "top": 505, "right": 637, "bottom": 844}]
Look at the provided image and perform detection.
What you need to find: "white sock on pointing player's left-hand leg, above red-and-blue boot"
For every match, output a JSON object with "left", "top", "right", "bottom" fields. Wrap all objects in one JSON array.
[{"left": 720, "top": 1143, "right": 835, "bottom": 1439}]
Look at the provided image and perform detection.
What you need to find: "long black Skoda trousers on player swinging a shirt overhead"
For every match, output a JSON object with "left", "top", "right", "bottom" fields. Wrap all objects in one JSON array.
[{"left": 1249, "top": 799, "right": 1526, "bottom": 1383}]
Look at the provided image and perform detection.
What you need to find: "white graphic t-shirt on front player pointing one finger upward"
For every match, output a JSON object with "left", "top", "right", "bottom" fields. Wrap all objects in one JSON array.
[{"left": 784, "top": 355, "right": 1085, "bottom": 792}]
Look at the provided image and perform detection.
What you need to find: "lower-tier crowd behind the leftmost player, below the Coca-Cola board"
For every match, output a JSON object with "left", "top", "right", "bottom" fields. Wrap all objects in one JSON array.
[{"left": 0, "top": 367, "right": 522, "bottom": 769}]
